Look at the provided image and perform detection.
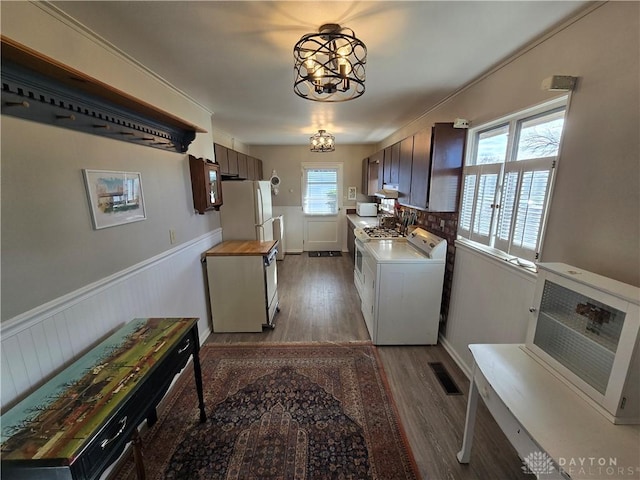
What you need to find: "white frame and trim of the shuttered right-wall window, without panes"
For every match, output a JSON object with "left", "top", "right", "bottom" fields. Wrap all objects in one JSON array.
[{"left": 457, "top": 92, "right": 571, "bottom": 267}]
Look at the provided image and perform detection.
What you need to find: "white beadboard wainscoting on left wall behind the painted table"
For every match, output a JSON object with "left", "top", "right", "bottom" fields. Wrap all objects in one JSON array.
[{"left": 0, "top": 229, "right": 222, "bottom": 410}]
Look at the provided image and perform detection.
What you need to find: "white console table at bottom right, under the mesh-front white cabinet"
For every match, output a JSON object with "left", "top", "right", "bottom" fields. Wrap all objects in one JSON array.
[{"left": 457, "top": 344, "right": 640, "bottom": 480}]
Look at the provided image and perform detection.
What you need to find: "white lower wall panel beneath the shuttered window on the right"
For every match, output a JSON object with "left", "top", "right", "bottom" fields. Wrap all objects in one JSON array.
[{"left": 441, "top": 242, "right": 536, "bottom": 376}]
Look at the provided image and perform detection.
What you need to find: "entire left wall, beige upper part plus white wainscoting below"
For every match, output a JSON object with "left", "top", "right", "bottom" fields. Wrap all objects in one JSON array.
[{"left": 0, "top": 2, "right": 221, "bottom": 406}]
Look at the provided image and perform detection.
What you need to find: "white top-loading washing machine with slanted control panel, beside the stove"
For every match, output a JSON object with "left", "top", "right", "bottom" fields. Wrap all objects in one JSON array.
[{"left": 361, "top": 228, "right": 447, "bottom": 345}]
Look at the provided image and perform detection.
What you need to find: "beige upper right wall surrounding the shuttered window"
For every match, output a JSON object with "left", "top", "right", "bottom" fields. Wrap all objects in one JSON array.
[{"left": 379, "top": 2, "right": 640, "bottom": 286}]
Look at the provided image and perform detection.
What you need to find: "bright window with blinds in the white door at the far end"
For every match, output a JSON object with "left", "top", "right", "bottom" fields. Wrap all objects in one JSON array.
[{"left": 302, "top": 167, "right": 338, "bottom": 215}]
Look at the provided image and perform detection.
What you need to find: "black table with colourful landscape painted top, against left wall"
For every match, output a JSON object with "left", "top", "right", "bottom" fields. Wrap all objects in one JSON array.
[{"left": 0, "top": 318, "right": 206, "bottom": 480}]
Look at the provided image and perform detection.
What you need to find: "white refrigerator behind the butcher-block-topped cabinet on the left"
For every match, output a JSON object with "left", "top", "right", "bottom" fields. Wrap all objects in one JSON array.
[{"left": 220, "top": 180, "right": 273, "bottom": 242}]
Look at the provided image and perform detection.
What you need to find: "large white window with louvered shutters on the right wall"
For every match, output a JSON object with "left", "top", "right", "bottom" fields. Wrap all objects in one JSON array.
[{"left": 458, "top": 97, "right": 568, "bottom": 261}]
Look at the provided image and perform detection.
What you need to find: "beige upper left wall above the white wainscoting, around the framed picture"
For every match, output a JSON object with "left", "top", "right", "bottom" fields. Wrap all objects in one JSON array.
[{"left": 1, "top": 2, "right": 220, "bottom": 322}]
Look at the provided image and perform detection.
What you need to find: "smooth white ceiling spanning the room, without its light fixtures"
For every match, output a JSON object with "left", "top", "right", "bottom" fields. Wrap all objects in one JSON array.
[{"left": 52, "top": 1, "right": 588, "bottom": 145}]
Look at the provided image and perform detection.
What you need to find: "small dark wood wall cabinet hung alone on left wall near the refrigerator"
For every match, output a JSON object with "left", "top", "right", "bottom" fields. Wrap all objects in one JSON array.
[{"left": 189, "top": 155, "right": 222, "bottom": 215}]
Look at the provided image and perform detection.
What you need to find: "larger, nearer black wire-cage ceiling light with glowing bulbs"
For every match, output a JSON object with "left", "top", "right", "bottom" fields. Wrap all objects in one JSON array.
[{"left": 293, "top": 23, "right": 367, "bottom": 102}]
